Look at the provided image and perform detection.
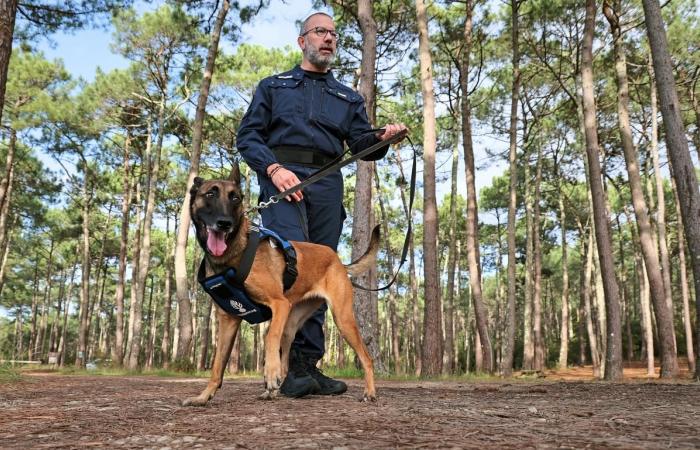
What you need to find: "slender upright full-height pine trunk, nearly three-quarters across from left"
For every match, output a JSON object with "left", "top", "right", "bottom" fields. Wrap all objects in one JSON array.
[{"left": 501, "top": 0, "right": 520, "bottom": 377}]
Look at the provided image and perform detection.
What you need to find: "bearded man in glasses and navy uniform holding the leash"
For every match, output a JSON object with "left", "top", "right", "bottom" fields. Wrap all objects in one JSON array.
[{"left": 237, "top": 13, "right": 406, "bottom": 397}]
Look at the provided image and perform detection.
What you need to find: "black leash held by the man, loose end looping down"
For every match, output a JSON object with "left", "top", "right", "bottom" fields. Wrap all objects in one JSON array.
[{"left": 245, "top": 128, "right": 417, "bottom": 292}]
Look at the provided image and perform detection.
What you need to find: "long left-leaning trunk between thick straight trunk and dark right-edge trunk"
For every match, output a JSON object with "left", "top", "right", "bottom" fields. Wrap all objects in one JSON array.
[{"left": 603, "top": 0, "right": 678, "bottom": 378}]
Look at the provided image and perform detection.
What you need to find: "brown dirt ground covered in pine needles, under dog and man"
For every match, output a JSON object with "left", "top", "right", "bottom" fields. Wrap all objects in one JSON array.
[{"left": 0, "top": 371, "right": 700, "bottom": 450}]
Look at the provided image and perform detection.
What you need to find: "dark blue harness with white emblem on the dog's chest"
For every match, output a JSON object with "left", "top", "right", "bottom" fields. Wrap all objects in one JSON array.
[{"left": 197, "top": 225, "right": 298, "bottom": 324}]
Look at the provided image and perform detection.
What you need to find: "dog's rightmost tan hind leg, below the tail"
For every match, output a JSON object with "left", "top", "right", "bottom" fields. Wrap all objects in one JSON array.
[{"left": 327, "top": 274, "right": 377, "bottom": 401}]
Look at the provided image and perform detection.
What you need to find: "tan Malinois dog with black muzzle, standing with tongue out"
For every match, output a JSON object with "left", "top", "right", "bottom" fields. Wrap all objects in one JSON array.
[{"left": 183, "top": 164, "right": 379, "bottom": 406}]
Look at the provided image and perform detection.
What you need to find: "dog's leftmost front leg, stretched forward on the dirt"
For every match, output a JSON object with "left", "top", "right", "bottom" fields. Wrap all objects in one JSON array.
[{"left": 182, "top": 307, "right": 241, "bottom": 406}]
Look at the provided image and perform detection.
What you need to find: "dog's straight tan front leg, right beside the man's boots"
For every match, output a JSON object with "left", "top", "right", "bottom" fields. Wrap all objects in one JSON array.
[{"left": 260, "top": 297, "right": 292, "bottom": 400}]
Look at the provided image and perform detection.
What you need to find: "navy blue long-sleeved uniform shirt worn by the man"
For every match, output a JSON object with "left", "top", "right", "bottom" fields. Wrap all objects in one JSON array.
[{"left": 236, "top": 66, "right": 388, "bottom": 176}]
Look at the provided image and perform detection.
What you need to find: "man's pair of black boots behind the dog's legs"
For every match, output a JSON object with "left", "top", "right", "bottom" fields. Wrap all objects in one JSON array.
[{"left": 280, "top": 348, "right": 348, "bottom": 398}]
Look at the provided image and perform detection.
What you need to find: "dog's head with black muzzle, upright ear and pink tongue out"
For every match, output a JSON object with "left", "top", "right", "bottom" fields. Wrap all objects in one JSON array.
[{"left": 190, "top": 164, "right": 244, "bottom": 257}]
